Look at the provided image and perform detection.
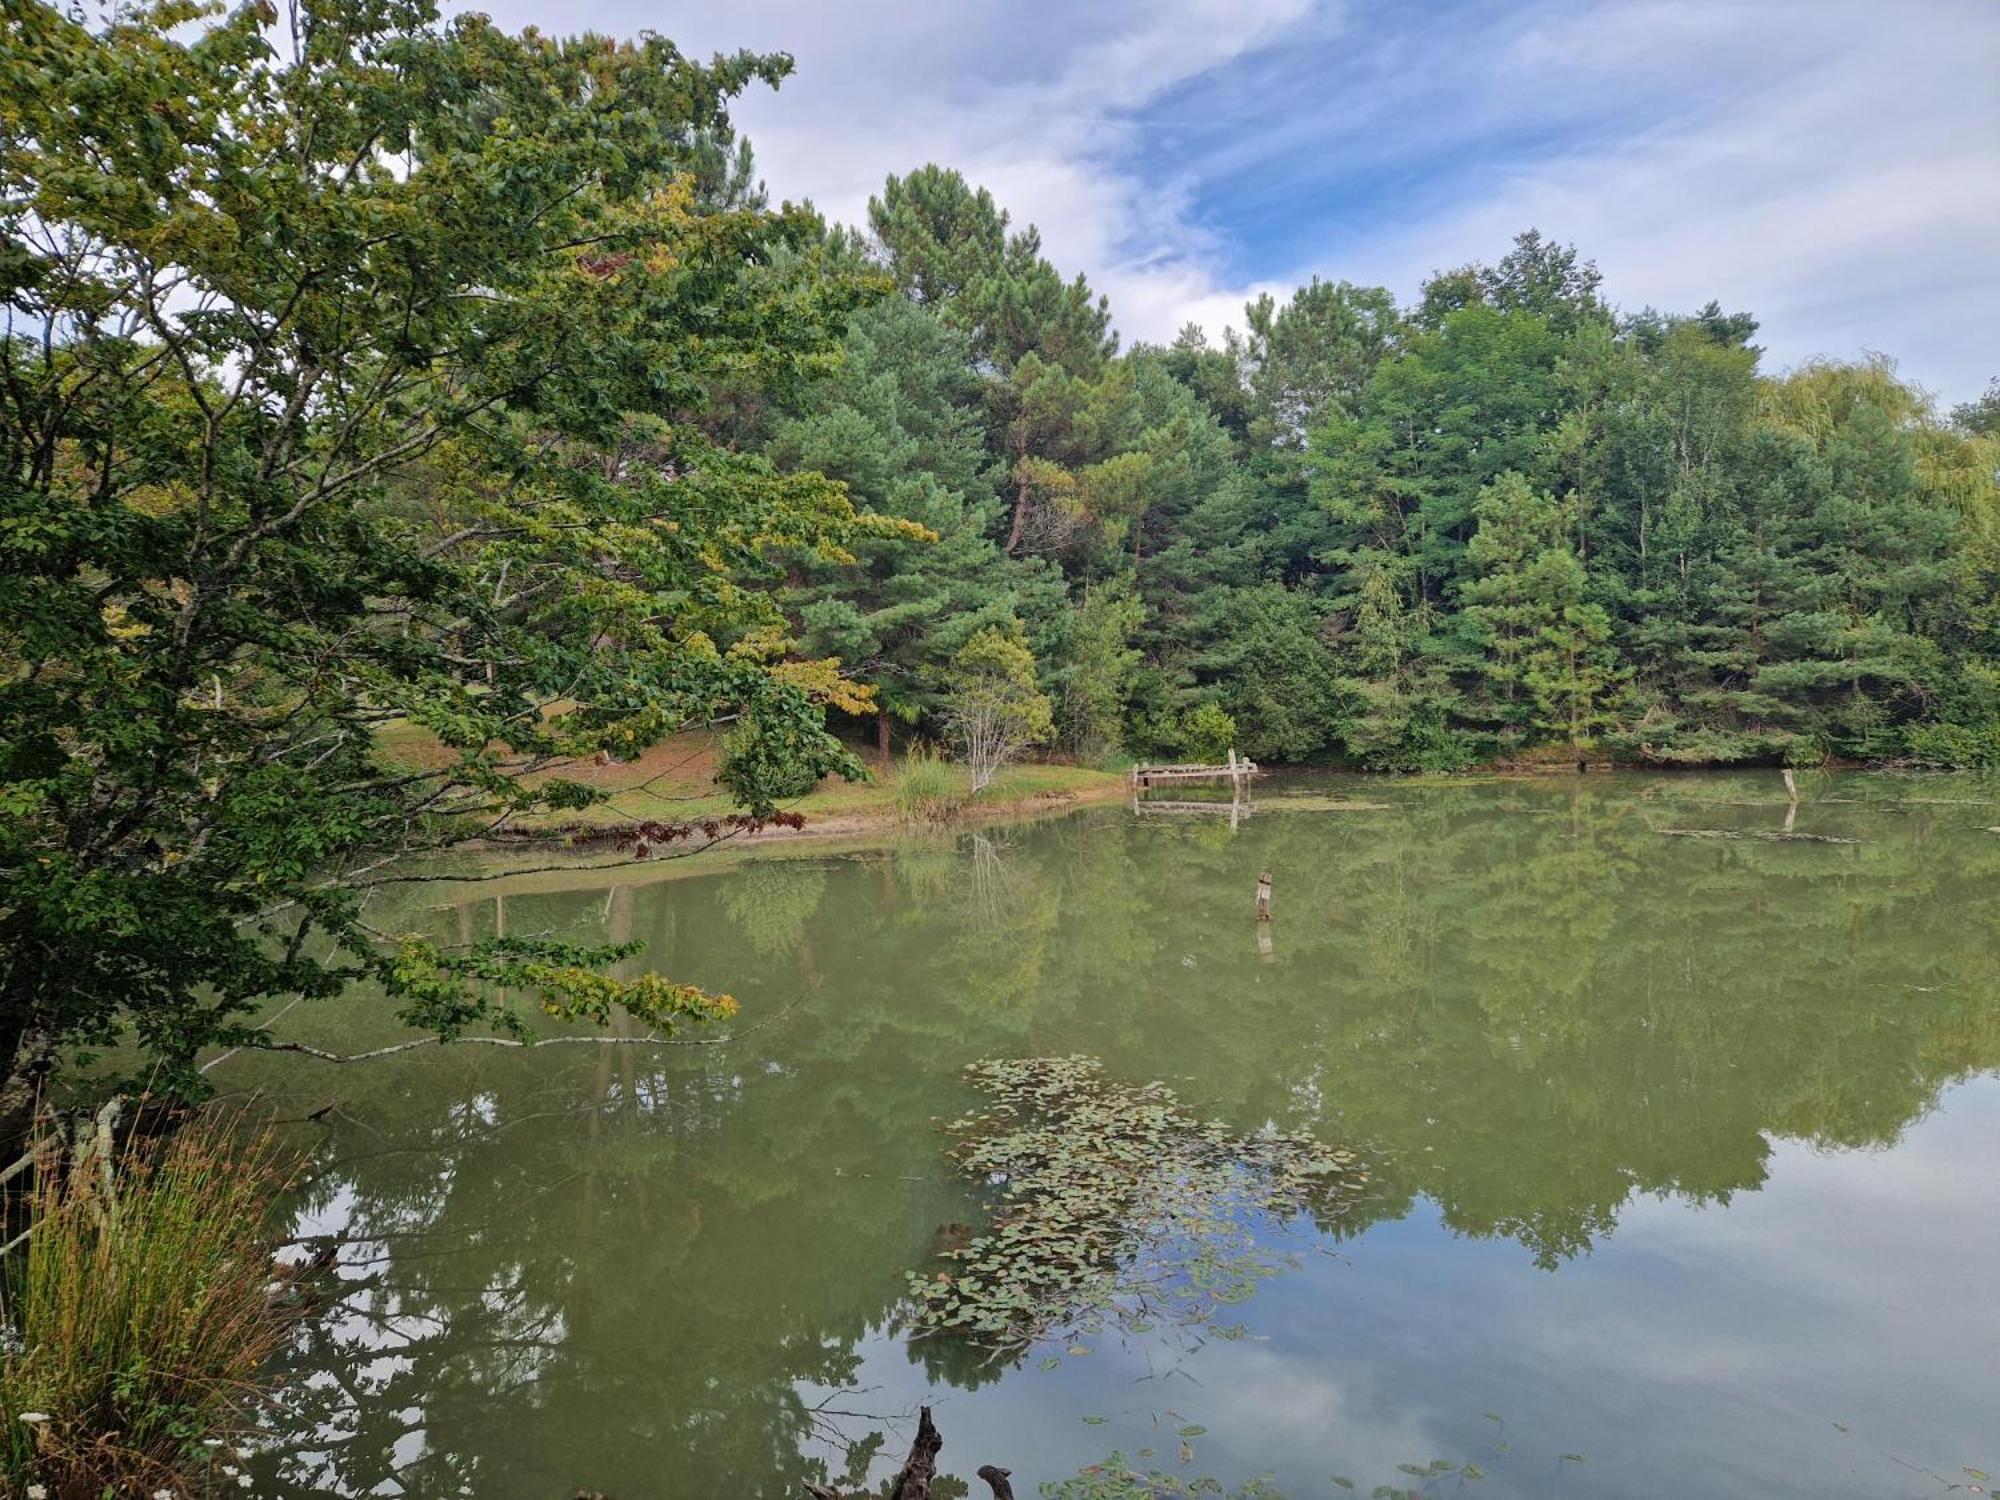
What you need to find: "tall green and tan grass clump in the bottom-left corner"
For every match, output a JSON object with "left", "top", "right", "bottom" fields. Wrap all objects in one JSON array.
[{"left": 0, "top": 1120, "right": 296, "bottom": 1500}]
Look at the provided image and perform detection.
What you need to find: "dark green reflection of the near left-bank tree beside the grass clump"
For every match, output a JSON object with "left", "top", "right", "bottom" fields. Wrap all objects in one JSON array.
[{"left": 250, "top": 1060, "right": 906, "bottom": 1496}]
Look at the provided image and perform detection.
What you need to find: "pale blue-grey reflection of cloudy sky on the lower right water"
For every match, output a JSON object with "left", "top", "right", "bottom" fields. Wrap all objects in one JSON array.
[{"left": 810, "top": 1078, "right": 2000, "bottom": 1498}]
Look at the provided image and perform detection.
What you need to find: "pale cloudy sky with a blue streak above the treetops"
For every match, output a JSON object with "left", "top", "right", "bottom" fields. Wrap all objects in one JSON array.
[{"left": 458, "top": 0, "right": 2000, "bottom": 402}]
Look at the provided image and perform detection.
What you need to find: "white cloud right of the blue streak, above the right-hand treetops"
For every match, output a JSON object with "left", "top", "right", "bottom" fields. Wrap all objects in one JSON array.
[{"left": 1336, "top": 2, "right": 2000, "bottom": 398}]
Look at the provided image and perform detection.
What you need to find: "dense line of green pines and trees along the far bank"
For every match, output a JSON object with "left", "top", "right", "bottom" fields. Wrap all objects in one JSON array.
[{"left": 708, "top": 162, "right": 2000, "bottom": 770}]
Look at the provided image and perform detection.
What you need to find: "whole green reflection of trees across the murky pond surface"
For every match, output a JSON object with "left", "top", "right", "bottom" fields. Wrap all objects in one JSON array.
[{"left": 232, "top": 778, "right": 2000, "bottom": 1496}]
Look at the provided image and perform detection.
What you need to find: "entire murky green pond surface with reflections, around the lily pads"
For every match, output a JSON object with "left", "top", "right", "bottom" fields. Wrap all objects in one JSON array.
[{"left": 214, "top": 772, "right": 2000, "bottom": 1500}]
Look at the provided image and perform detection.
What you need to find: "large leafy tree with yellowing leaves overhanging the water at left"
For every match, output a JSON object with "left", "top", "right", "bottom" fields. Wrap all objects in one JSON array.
[{"left": 0, "top": 0, "right": 884, "bottom": 1134}]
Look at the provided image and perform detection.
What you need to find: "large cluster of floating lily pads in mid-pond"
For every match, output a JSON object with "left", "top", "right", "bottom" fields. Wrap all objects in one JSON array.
[{"left": 910, "top": 1056, "right": 1366, "bottom": 1358}]
